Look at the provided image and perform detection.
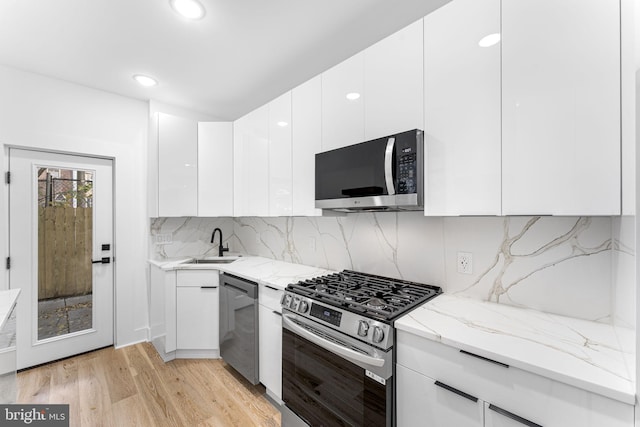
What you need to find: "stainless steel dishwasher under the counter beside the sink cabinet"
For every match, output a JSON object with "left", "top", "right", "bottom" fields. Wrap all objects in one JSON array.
[{"left": 220, "top": 273, "right": 260, "bottom": 384}]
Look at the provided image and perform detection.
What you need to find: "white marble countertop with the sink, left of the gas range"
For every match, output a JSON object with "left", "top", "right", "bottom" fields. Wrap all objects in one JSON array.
[{"left": 149, "top": 256, "right": 334, "bottom": 289}]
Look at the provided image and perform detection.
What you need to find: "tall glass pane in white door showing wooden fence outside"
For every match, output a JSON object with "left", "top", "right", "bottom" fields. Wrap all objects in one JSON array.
[{"left": 36, "top": 167, "right": 94, "bottom": 340}]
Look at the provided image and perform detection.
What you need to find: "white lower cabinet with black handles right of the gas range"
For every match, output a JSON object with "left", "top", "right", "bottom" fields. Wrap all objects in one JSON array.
[{"left": 396, "top": 331, "right": 634, "bottom": 427}]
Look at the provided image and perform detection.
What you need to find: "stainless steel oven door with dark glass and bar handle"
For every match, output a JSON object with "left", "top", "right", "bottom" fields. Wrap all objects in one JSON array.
[{"left": 282, "top": 310, "right": 393, "bottom": 427}]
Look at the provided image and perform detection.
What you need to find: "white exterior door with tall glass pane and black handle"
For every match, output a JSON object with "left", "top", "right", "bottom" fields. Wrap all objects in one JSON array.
[{"left": 9, "top": 148, "right": 114, "bottom": 369}]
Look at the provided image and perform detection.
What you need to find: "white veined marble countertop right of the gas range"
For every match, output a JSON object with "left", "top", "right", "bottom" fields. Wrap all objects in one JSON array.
[{"left": 395, "top": 294, "right": 635, "bottom": 405}]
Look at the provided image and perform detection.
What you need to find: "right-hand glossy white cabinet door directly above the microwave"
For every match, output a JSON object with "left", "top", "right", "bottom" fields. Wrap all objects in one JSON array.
[{"left": 364, "top": 20, "right": 424, "bottom": 142}]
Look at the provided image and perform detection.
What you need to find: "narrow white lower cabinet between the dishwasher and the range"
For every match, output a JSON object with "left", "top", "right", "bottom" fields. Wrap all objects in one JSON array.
[{"left": 258, "top": 285, "right": 283, "bottom": 403}]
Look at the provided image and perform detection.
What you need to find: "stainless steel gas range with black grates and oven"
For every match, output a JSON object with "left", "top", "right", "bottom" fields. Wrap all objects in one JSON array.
[{"left": 281, "top": 270, "right": 442, "bottom": 427}]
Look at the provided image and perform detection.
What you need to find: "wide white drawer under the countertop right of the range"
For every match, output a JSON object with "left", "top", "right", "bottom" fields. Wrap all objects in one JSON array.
[{"left": 397, "top": 331, "right": 633, "bottom": 427}]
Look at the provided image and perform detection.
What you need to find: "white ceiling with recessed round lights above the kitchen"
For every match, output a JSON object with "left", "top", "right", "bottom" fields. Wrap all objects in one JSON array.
[{"left": 0, "top": 0, "right": 449, "bottom": 120}]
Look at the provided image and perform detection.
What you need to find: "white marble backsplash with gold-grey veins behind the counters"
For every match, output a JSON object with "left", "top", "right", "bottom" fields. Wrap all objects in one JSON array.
[{"left": 150, "top": 212, "right": 635, "bottom": 327}]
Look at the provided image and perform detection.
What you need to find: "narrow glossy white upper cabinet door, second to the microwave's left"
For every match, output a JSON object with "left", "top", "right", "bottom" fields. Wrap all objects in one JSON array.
[{"left": 269, "top": 92, "right": 292, "bottom": 216}]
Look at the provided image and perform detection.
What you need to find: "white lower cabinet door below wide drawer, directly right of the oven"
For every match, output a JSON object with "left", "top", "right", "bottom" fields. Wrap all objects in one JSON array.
[{"left": 396, "top": 365, "right": 484, "bottom": 427}]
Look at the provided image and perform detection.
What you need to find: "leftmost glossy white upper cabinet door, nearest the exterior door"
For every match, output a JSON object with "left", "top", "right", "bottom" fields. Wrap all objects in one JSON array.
[{"left": 158, "top": 113, "right": 198, "bottom": 217}]
